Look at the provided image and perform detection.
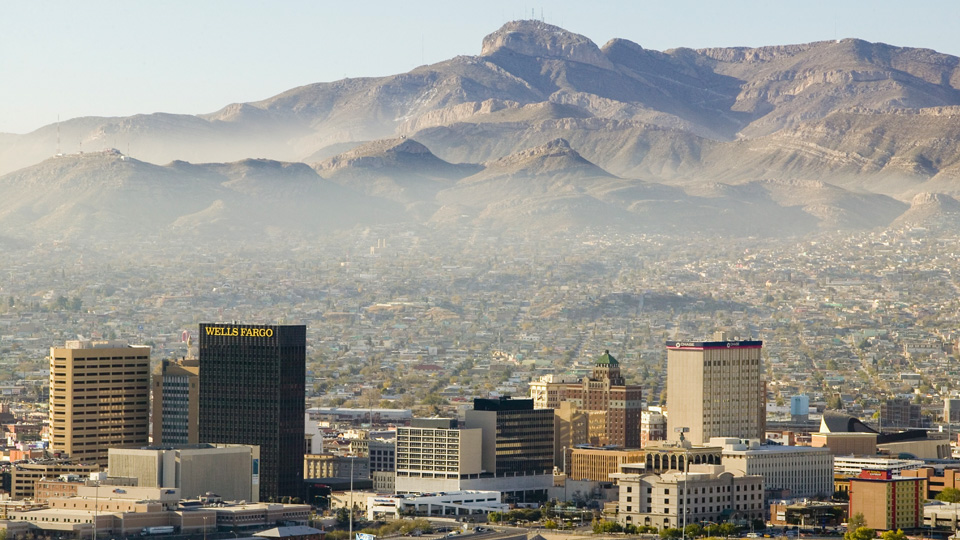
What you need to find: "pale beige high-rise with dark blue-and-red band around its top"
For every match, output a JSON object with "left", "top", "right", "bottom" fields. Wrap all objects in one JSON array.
[{"left": 667, "top": 333, "right": 766, "bottom": 444}]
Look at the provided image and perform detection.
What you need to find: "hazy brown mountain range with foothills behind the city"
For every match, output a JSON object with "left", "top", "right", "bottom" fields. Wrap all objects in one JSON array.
[{"left": 0, "top": 21, "right": 960, "bottom": 240}]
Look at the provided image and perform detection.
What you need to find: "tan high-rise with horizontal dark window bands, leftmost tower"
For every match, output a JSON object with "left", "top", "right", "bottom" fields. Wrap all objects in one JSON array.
[{"left": 49, "top": 341, "right": 150, "bottom": 467}]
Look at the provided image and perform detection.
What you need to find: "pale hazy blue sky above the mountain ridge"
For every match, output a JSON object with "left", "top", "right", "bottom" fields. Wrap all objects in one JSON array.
[{"left": 0, "top": 0, "right": 960, "bottom": 133}]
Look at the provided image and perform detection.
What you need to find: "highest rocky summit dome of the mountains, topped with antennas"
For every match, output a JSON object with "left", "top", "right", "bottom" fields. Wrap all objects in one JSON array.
[{"left": 480, "top": 20, "right": 613, "bottom": 69}]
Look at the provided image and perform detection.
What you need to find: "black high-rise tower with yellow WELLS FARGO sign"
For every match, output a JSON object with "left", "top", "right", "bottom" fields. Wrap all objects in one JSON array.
[{"left": 199, "top": 323, "right": 307, "bottom": 501}]
